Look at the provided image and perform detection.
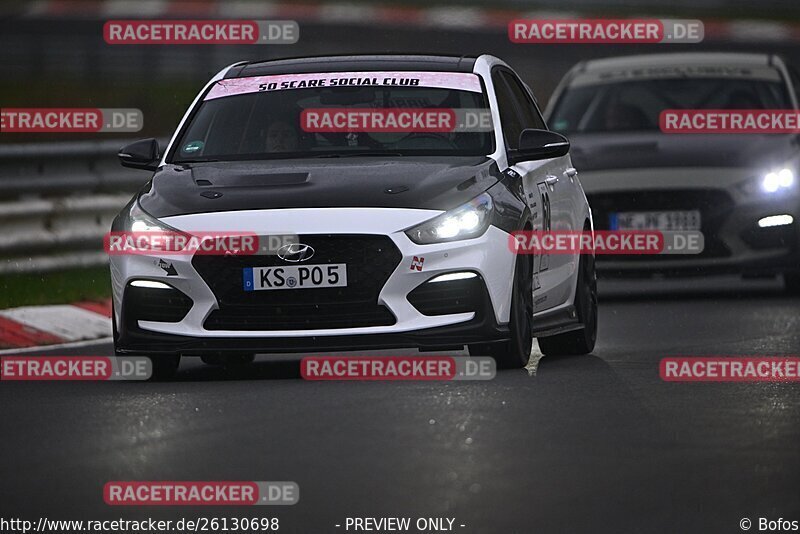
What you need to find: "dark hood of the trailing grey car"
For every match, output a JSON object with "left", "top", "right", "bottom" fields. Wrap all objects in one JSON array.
[{"left": 569, "top": 132, "right": 798, "bottom": 171}]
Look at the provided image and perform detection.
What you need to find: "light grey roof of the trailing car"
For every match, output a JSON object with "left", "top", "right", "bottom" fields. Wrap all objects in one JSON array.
[{"left": 579, "top": 52, "right": 772, "bottom": 72}]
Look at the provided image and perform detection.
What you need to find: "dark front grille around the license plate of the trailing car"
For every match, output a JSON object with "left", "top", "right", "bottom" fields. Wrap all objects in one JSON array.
[{"left": 587, "top": 189, "right": 733, "bottom": 262}]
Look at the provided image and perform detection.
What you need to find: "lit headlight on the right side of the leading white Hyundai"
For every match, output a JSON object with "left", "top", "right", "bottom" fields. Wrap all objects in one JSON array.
[{"left": 406, "top": 193, "right": 493, "bottom": 245}]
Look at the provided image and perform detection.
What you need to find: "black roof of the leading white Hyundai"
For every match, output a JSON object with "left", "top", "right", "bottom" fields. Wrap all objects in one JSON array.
[{"left": 225, "top": 54, "right": 476, "bottom": 78}]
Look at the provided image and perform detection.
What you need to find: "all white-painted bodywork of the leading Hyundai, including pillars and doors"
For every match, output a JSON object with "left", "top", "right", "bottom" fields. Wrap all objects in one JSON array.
[{"left": 111, "top": 56, "right": 591, "bottom": 348}]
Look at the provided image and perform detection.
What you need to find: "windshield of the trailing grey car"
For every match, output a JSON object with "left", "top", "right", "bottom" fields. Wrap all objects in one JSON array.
[{"left": 549, "top": 78, "right": 791, "bottom": 133}]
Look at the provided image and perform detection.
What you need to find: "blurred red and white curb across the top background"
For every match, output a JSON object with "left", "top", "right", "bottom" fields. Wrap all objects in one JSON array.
[{"left": 23, "top": 0, "right": 800, "bottom": 42}]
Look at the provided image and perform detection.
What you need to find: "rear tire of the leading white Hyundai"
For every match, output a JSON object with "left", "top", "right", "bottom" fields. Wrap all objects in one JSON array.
[{"left": 538, "top": 254, "right": 597, "bottom": 356}]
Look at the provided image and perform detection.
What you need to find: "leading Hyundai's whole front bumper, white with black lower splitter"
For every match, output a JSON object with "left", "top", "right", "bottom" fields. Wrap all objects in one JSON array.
[{"left": 111, "top": 208, "right": 515, "bottom": 353}]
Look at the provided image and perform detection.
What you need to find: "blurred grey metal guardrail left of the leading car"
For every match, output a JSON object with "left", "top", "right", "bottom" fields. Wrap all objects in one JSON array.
[{"left": 0, "top": 140, "right": 165, "bottom": 274}]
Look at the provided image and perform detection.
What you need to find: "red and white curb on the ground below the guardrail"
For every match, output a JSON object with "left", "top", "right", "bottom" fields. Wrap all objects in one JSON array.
[{"left": 0, "top": 300, "right": 111, "bottom": 353}]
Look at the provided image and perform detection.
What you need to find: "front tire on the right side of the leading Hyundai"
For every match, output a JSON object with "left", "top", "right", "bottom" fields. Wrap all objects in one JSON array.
[{"left": 469, "top": 255, "right": 533, "bottom": 369}]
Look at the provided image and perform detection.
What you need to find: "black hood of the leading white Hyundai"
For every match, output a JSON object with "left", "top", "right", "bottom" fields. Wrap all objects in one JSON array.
[{"left": 140, "top": 156, "right": 500, "bottom": 217}]
